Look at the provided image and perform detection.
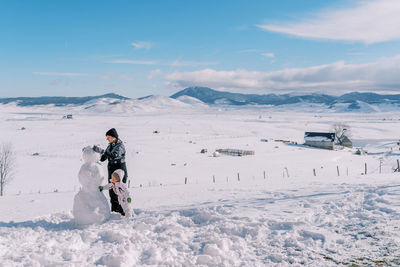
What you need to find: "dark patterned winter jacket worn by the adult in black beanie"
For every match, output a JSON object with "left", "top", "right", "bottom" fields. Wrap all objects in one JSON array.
[{"left": 100, "top": 140, "right": 128, "bottom": 183}]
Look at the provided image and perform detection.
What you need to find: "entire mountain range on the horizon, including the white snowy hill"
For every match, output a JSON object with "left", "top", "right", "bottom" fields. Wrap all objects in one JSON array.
[{"left": 0, "top": 87, "right": 400, "bottom": 113}]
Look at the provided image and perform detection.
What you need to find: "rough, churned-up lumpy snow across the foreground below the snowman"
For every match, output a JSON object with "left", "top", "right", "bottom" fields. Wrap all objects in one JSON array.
[{"left": 0, "top": 184, "right": 400, "bottom": 266}]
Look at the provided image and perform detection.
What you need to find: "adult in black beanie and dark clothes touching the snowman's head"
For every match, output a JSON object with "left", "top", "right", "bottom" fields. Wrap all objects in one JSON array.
[{"left": 93, "top": 128, "right": 128, "bottom": 215}]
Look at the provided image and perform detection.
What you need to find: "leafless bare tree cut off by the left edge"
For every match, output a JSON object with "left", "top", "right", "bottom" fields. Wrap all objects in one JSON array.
[{"left": 0, "top": 143, "right": 15, "bottom": 196}]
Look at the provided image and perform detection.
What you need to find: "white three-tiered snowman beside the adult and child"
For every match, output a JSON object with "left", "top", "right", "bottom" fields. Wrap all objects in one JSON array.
[{"left": 72, "top": 146, "right": 110, "bottom": 225}]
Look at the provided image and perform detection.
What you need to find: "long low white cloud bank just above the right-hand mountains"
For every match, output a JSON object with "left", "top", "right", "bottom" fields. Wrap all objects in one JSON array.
[{"left": 165, "top": 55, "right": 400, "bottom": 92}]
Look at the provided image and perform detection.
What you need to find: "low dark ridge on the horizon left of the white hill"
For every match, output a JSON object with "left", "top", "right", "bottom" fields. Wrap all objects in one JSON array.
[{"left": 0, "top": 93, "right": 129, "bottom": 106}]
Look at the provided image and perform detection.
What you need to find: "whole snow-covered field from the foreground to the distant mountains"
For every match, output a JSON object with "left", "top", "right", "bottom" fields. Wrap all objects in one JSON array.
[{"left": 0, "top": 97, "right": 400, "bottom": 266}]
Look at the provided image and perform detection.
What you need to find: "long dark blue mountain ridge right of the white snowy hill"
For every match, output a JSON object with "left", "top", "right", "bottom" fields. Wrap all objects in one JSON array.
[{"left": 171, "top": 87, "right": 400, "bottom": 109}]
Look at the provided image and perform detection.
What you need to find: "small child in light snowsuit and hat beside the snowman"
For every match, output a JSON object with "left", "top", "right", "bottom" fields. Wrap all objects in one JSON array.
[{"left": 99, "top": 169, "right": 132, "bottom": 218}]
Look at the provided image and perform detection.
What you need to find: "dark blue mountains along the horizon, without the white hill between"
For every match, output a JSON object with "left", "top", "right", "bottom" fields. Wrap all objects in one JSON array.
[{"left": 0, "top": 87, "right": 400, "bottom": 110}]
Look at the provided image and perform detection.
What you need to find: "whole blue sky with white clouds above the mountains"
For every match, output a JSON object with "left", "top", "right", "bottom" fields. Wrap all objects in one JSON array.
[{"left": 0, "top": 0, "right": 400, "bottom": 97}]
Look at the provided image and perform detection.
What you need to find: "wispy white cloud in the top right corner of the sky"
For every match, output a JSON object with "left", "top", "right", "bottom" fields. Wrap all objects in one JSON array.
[{"left": 257, "top": 0, "right": 400, "bottom": 44}]
